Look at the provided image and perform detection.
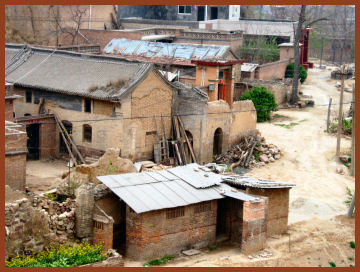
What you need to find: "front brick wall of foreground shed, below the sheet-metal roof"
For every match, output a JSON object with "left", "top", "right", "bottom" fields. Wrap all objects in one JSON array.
[{"left": 126, "top": 200, "right": 217, "bottom": 259}]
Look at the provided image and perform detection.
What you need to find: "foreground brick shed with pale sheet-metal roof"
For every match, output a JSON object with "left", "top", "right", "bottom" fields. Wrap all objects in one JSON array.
[{"left": 94, "top": 164, "right": 267, "bottom": 260}]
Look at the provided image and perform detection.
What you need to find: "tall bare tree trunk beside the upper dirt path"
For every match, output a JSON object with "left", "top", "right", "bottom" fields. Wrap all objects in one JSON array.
[{"left": 290, "top": 5, "right": 306, "bottom": 104}]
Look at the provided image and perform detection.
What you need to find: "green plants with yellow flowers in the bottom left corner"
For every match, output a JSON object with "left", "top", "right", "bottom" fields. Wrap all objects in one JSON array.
[{"left": 5, "top": 241, "right": 106, "bottom": 267}]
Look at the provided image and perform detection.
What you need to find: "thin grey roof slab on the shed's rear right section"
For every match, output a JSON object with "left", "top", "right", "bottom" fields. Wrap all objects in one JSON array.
[{"left": 222, "top": 176, "right": 296, "bottom": 189}]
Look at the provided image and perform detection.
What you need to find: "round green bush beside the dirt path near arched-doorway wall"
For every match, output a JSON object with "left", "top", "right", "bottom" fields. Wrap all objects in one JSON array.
[{"left": 240, "top": 86, "right": 277, "bottom": 122}]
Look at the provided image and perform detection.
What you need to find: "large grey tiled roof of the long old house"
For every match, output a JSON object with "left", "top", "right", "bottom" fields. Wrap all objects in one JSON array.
[{"left": 5, "top": 44, "right": 152, "bottom": 100}]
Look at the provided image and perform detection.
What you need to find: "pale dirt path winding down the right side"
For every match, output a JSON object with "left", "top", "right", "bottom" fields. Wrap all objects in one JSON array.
[{"left": 125, "top": 66, "right": 355, "bottom": 267}]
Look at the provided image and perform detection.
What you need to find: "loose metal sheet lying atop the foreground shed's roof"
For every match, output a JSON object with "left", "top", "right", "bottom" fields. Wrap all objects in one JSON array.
[{"left": 168, "top": 163, "right": 222, "bottom": 188}]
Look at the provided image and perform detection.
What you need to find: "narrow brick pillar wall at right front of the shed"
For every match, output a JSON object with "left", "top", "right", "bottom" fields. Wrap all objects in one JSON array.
[{"left": 241, "top": 200, "right": 266, "bottom": 254}]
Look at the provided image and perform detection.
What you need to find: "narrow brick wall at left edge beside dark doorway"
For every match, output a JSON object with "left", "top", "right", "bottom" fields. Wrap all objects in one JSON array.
[{"left": 5, "top": 123, "right": 27, "bottom": 191}]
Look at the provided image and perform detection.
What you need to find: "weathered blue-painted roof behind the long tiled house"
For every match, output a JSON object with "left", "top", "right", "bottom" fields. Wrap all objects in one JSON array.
[{"left": 104, "top": 38, "right": 230, "bottom": 60}]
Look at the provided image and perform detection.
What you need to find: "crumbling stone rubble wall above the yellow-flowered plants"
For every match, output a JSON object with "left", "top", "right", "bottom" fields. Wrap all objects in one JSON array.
[{"left": 5, "top": 198, "right": 54, "bottom": 258}]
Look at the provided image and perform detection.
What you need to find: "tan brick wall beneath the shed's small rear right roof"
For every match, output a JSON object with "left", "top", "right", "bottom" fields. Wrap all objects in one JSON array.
[{"left": 246, "top": 188, "right": 290, "bottom": 236}]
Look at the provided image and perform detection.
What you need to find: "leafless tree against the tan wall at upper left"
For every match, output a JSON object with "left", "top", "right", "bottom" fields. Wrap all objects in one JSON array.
[{"left": 53, "top": 5, "right": 88, "bottom": 45}]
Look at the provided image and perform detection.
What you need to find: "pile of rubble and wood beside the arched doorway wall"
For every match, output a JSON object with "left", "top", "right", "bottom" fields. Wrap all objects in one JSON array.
[{"left": 214, "top": 135, "right": 281, "bottom": 171}]
